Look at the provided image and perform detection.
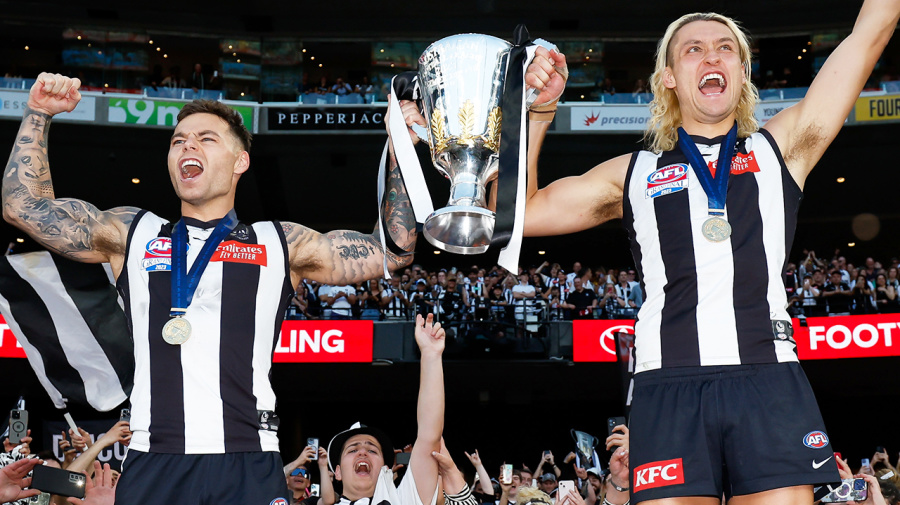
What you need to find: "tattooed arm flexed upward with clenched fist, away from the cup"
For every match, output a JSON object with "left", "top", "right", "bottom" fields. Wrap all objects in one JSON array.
[{"left": 0, "top": 74, "right": 138, "bottom": 273}]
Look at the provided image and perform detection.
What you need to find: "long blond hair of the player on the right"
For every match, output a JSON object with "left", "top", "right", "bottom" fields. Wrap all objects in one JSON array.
[{"left": 644, "top": 12, "right": 759, "bottom": 153}]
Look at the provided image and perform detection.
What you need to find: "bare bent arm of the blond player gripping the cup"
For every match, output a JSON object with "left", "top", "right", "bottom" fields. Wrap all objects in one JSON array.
[{"left": 525, "top": 48, "right": 630, "bottom": 237}]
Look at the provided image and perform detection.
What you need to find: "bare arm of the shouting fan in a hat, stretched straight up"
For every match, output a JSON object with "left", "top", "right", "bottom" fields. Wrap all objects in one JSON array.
[{"left": 409, "top": 314, "right": 444, "bottom": 504}]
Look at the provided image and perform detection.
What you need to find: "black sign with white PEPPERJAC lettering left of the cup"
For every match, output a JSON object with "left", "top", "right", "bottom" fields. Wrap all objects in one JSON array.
[{"left": 267, "top": 105, "right": 386, "bottom": 131}]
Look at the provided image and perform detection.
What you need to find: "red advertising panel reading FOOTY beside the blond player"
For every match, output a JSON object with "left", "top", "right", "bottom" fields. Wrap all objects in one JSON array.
[{"left": 794, "top": 314, "right": 900, "bottom": 359}]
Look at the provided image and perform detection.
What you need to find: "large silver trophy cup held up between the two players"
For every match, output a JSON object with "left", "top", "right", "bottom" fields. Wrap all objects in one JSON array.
[{"left": 419, "top": 34, "right": 511, "bottom": 254}]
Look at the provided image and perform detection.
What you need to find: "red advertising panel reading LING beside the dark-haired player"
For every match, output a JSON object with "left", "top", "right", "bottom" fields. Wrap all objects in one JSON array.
[{"left": 273, "top": 320, "right": 373, "bottom": 363}]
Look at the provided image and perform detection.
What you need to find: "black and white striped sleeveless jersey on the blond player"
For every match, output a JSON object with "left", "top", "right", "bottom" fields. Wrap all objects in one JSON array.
[{"left": 623, "top": 130, "right": 802, "bottom": 373}]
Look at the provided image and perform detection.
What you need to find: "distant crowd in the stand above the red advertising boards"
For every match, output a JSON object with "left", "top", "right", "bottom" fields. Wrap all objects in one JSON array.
[{"left": 287, "top": 250, "right": 900, "bottom": 327}]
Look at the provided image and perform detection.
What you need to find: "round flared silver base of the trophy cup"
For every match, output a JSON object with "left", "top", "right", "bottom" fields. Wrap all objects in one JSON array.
[{"left": 423, "top": 205, "right": 494, "bottom": 254}]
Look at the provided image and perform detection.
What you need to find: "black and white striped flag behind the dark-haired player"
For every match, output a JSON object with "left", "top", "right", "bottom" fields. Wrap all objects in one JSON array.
[{"left": 0, "top": 251, "right": 134, "bottom": 412}]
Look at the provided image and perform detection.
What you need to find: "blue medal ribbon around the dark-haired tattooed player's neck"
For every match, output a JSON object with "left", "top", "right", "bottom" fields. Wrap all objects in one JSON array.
[{"left": 169, "top": 209, "right": 237, "bottom": 317}]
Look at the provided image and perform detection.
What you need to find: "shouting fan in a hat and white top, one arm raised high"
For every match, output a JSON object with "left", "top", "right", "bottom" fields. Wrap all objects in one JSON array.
[{"left": 328, "top": 314, "right": 444, "bottom": 505}]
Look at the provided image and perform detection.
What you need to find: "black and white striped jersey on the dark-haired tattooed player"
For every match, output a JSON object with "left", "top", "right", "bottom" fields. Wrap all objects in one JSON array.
[{"left": 117, "top": 211, "right": 293, "bottom": 454}]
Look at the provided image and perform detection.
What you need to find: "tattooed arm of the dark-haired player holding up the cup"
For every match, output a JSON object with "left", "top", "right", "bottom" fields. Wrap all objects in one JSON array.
[{"left": 282, "top": 144, "right": 416, "bottom": 285}]
